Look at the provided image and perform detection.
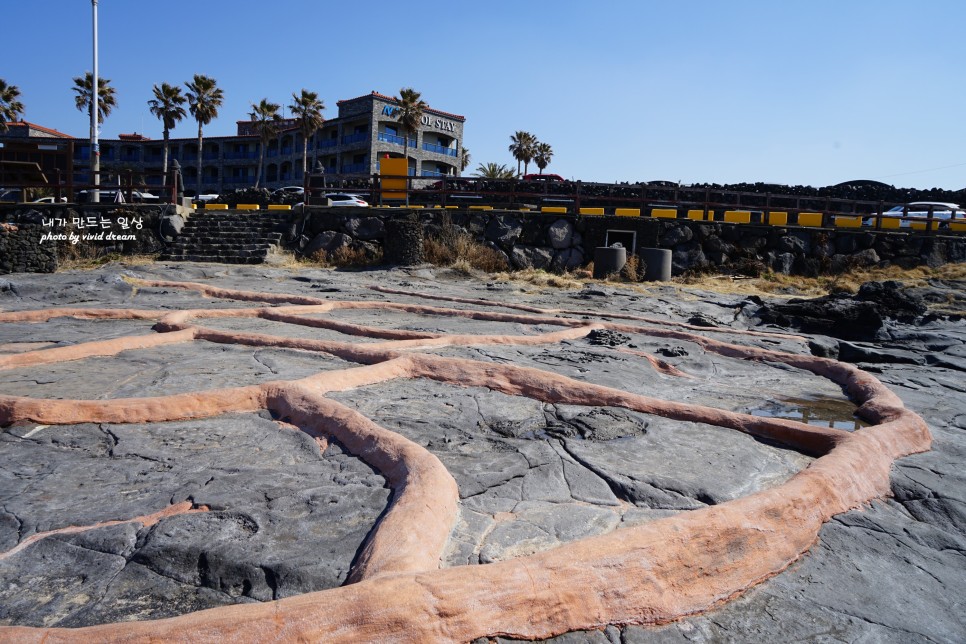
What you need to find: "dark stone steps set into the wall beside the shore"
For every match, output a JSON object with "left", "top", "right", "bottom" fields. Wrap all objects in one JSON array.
[{"left": 160, "top": 210, "right": 290, "bottom": 264}]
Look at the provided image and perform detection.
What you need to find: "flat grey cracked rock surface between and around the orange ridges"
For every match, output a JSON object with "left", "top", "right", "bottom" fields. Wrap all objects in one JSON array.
[{"left": 0, "top": 263, "right": 966, "bottom": 642}]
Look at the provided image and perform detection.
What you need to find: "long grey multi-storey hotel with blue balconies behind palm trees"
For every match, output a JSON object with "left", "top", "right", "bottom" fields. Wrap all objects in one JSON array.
[{"left": 0, "top": 92, "right": 466, "bottom": 195}]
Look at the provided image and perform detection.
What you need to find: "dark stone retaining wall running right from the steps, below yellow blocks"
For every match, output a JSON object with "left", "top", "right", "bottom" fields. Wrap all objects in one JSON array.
[{"left": 290, "top": 209, "right": 966, "bottom": 276}]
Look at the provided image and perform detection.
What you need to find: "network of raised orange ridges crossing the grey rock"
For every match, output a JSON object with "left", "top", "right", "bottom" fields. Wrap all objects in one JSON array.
[{"left": 0, "top": 281, "right": 931, "bottom": 643}]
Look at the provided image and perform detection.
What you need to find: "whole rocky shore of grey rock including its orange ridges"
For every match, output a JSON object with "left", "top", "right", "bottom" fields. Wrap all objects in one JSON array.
[{"left": 0, "top": 263, "right": 966, "bottom": 642}]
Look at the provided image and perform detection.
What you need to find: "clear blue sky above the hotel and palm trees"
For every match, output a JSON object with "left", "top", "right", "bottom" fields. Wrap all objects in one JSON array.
[{"left": 7, "top": 0, "right": 966, "bottom": 190}]
